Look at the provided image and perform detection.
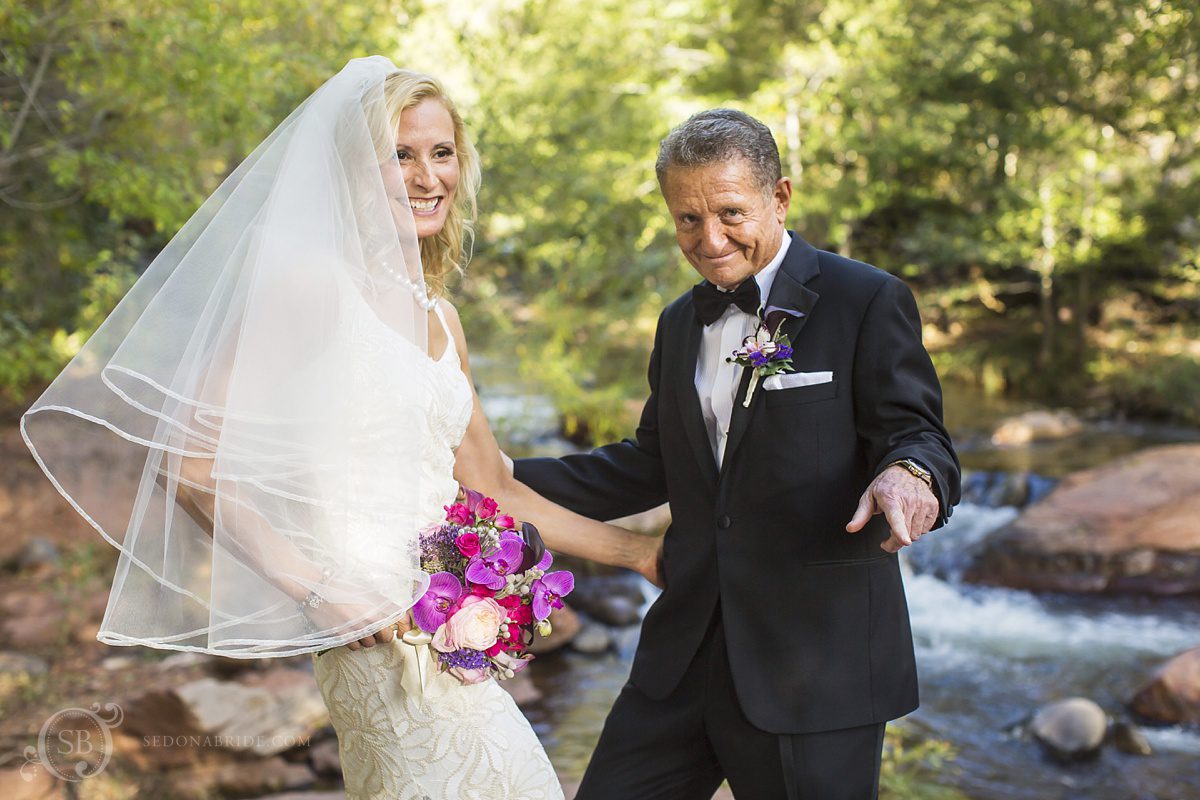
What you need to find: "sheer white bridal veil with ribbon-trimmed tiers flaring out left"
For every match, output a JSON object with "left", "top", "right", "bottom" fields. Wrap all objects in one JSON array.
[{"left": 20, "top": 56, "right": 436, "bottom": 658}]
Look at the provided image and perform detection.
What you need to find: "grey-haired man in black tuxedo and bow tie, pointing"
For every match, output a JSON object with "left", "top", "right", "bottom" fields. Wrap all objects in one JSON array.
[{"left": 516, "top": 109, "right": 959, "bottom": 800}]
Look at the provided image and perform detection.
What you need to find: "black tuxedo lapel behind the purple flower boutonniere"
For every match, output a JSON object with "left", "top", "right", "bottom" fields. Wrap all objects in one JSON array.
[{"left": 719, "top": 231, "right": 821, "bottom": 480}]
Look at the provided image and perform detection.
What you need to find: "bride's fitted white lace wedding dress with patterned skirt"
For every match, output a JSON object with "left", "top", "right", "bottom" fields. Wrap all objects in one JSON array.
[{"left": 312, "top": 306, "right": 563, "bottom": 800}]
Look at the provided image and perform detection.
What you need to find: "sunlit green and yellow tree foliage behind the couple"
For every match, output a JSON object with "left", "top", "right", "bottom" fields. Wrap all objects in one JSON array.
[{"left": 0, "top": 0, "right": 1200, "bottom": 440}]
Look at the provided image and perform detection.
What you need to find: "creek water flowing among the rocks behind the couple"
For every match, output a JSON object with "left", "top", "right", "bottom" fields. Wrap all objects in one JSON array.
[{"left": 475, "top": 367, "right": 1200, "bottom": 800}]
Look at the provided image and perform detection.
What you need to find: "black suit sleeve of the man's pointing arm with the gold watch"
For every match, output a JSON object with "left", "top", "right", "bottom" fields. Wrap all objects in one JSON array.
[{"left": 854, "top": 276, "right": 961, "bottom": 528}]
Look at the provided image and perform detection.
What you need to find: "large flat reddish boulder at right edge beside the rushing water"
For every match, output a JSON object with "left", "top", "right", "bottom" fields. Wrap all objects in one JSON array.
[{"left": 964, "top": 444, "right": 1200, "bottom": 596}]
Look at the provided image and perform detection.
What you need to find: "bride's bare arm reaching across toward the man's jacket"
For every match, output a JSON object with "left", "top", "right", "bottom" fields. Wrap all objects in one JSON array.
[{"left": 443, "top": 301, "right": 661, "bottom": 583}]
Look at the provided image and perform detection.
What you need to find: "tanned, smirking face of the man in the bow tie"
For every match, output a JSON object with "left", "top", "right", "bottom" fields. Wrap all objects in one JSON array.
[{"left": 662, "top": 158, "right": 792, "bottom": 289}]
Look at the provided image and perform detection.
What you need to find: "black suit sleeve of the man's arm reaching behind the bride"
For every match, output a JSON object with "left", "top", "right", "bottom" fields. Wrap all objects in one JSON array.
[{"left": 514, "top": 312, "right": 667, "bottom": 519}]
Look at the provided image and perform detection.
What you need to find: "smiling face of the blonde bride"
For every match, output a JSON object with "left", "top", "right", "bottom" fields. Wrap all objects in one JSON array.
[{"left": 384, "top": 97, "right": 458, "bottom": 239}]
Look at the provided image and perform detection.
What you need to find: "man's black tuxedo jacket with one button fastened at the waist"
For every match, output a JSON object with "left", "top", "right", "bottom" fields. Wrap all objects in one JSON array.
[{"left": 516, "top": 234, "right": 959, "bottom": 734}]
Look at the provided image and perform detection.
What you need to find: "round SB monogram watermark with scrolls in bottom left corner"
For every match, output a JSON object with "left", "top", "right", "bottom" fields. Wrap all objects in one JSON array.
[{"left": 20, "top": 703, "right": 125, "bottom": 782}]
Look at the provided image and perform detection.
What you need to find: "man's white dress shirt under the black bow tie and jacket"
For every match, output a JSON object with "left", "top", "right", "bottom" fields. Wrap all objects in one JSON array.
[{"left": 696, "top": 231, "right": 792, "bottom": 469}]
